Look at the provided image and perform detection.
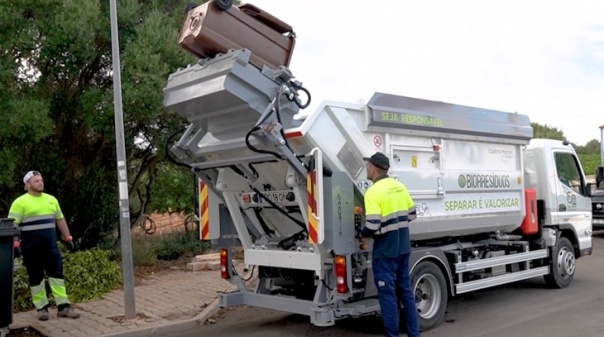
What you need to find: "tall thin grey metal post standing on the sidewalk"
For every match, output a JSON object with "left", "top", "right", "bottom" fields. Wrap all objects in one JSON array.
[{"left": 109, "top": 0, "right": 136, "bottom": 319}]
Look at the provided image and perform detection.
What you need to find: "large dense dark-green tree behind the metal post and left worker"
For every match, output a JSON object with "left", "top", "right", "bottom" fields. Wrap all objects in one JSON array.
[{"left": 0, "top": 0, "right": 203, "bottom": 247}]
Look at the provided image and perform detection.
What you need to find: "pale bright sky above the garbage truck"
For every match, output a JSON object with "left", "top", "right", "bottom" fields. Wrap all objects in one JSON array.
[{"left": 248, "top": 0, "right": 604, "bottom": 145}]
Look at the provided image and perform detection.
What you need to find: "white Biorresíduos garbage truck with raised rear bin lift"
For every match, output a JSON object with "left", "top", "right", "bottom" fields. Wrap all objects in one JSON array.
[{"left": 163, "top": 2, "right": 592, "bottom": 330}]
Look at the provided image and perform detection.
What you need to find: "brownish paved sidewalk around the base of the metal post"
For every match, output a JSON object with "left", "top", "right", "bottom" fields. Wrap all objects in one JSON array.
[{"left": 9, "top": 262, "right": 235, "bottom": 337}]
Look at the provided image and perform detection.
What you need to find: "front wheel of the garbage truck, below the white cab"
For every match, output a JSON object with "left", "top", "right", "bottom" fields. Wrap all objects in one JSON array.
[{"left": 544, "top": 237, "right": 576, "bottom": 288}]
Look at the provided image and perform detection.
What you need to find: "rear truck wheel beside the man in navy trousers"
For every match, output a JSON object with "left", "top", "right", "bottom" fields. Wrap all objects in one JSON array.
[{"left": 410, "top": 261, "right": 449, "bottom": 331}]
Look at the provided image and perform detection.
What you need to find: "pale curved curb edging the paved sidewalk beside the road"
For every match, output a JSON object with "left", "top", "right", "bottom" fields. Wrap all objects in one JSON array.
[{"left": 99, "top": 298, "right": 220, "bottom": 337}]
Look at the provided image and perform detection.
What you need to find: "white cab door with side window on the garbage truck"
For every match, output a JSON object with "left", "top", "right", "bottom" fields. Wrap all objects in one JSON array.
[{"left": 552, "top": 149, "right": 591, "bottom": 225}]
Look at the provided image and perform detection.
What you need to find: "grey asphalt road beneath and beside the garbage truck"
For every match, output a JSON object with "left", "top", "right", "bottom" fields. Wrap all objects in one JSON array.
[{"left": 169, "top": 236, "right": 604, "bottom": 337}]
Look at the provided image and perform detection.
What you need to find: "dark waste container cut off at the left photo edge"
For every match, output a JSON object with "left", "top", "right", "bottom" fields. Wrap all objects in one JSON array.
[{"left": 0, "top": 219, "right": 19, "bottom": 330}]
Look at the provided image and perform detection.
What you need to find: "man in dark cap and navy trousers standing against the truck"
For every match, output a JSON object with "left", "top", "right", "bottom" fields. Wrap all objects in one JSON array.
[{"left": 361, "top": 152, "right": 419, "bottom": 337}]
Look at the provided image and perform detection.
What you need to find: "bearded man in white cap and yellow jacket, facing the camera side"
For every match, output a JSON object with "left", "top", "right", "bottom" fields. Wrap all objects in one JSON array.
[{"left": 8, "top": 171, "right": 80, "bottom": 321}]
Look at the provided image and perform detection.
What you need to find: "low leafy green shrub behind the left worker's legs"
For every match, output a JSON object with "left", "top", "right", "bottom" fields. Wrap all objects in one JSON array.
[{"left": 14, "top": 248, "right": 121, "bottom": 312}]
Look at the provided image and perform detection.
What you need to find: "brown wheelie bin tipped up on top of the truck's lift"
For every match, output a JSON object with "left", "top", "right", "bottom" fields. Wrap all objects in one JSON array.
[{"left": 178, "top": 0, "right": 296, "bottom": 68}]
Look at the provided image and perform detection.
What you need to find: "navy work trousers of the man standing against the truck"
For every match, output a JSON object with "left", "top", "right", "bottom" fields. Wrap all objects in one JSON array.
[{"left": 373, "top": 253, "right": 419, "bottom": 337}]
